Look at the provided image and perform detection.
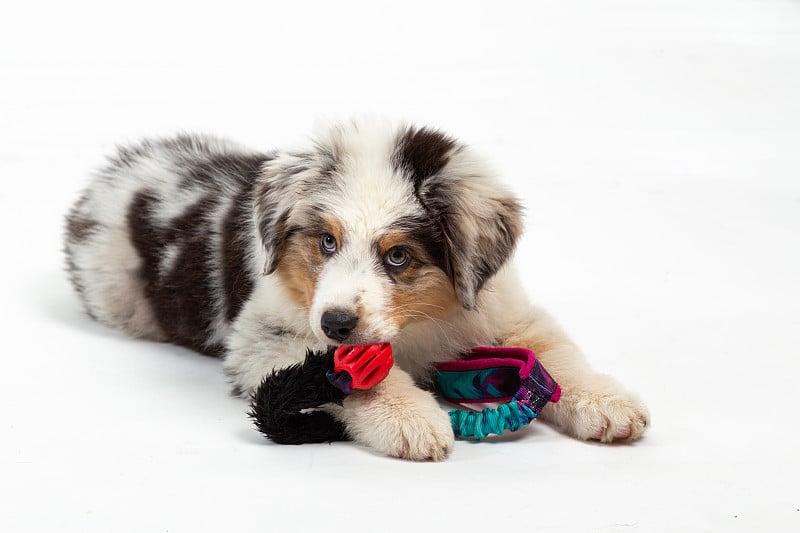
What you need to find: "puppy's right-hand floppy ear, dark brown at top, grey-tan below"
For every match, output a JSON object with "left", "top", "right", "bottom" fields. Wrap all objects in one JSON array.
[{"left": 395, "top": 128, "right": 523, "bottom": 309}]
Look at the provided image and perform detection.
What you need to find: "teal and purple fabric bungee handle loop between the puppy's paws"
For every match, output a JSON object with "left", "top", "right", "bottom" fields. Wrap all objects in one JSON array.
[{"left": 436, "top": 346, "right": 561, "bottom": 440}]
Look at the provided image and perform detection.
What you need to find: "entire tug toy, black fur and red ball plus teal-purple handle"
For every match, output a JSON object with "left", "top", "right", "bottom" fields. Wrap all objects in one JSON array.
[{"left": 250, "top": 343, "right": 561, "bottom": 444}]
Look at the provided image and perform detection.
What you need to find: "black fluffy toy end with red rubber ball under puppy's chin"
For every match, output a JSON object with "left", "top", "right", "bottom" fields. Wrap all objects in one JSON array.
[{"left": 250, "top": 343, "right": 394, "bottom": 444}]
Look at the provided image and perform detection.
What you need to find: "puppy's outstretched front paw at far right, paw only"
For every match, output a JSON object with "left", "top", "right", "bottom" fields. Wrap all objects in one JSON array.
[{"left": 542, "top": 375, "right": 650, "bottom": 442}]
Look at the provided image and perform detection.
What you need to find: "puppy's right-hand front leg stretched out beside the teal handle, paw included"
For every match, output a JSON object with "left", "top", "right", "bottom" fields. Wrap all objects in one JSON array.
[{"left": 502, "top": 309, "right": 650, "bottom": 442}]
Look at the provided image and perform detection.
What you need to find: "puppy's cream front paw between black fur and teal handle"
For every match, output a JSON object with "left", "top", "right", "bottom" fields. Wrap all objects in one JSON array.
[{"left": 334, "top": 366, "right": 454, "bottom": 461}]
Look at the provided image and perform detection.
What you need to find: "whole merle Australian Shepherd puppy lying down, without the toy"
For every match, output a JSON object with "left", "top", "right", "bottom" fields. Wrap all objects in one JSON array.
[{"left": 66, "top": 120, "right": 648, "bottom": 460}]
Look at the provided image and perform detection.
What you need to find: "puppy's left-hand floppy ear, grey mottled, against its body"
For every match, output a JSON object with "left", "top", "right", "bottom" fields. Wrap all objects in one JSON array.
[{"left": 254, "top": 144, "right": 336, "bottom": 275}]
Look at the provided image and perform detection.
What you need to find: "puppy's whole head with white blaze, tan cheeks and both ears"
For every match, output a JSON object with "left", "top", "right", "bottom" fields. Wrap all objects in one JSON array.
[{"left": 255, "top": 122, "right": 522, "bottom": 344}]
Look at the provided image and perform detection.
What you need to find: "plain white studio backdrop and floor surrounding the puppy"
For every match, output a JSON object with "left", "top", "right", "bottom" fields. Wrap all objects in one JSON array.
[{"left": 0, "top": 0, "right": 800, "bottom": 532}]
